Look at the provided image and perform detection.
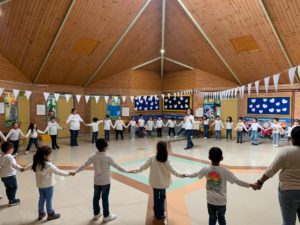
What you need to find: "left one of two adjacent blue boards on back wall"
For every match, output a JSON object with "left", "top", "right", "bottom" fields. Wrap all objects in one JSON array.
[{"left": 134, "top": 96, "right": 160, "bottom": 111}]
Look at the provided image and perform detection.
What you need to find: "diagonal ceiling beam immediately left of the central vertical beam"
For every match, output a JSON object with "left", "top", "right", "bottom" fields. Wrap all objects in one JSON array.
[{"left": 84, "top": 0, "right": 152, "bottom": 87}]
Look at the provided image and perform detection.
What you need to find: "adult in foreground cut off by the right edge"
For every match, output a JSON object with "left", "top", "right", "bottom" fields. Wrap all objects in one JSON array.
[{"left": 256, "top": 127, "right": 300, "bottom": 225}]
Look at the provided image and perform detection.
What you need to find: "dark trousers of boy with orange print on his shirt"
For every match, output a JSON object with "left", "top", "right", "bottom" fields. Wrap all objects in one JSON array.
[{"left": 207, "top": 203, "right": 226, "bottom": 225}]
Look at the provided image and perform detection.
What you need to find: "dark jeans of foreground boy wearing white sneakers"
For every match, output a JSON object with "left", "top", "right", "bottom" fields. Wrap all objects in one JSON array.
[{"left": 93, "top": 184, "right": 110, "bottom": 217}]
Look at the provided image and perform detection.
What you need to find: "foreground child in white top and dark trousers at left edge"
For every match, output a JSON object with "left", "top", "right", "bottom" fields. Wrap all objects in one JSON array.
[{"left": 0, "top": 141, "right": 24, "bottom": 206}]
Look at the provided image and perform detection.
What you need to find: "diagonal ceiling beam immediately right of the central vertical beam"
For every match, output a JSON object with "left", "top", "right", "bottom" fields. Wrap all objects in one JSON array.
[{"left": 177, "top": 0, "right": 242, "bottom": 85}]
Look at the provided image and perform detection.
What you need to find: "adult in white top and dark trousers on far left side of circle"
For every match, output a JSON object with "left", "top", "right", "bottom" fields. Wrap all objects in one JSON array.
[{"left": 66, "top": 108, "right": 85, "bottom": 147}]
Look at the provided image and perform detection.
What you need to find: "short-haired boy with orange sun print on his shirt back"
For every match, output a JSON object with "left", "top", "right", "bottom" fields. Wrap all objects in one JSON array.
[{"left": 189, "top": 147, "right": 255, "bottom": 225}]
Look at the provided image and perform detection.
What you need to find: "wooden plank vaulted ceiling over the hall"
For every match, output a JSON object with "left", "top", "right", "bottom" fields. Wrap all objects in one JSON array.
[{"left": 0, "top": 0, "right": 300, "bottom": 86}]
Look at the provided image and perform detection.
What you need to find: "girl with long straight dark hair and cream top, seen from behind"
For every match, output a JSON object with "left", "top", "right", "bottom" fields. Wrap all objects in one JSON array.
[{"left": 130, "top": 141, "right": 185, "bottom": 219}]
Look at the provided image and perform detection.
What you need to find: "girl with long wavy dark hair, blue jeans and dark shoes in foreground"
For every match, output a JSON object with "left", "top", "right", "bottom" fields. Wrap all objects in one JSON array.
[{"left": 26, "top": 146, "right": 73, "bottom": 221}]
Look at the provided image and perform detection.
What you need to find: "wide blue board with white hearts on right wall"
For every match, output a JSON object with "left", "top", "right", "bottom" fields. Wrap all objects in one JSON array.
[{"left": 247, "top": 97, "right": 291, "bottom": 115}]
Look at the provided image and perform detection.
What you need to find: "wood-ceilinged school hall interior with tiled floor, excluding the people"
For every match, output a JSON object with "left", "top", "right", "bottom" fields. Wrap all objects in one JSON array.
[{"left": 0, "top": 0, "right": 300, "bottom": 225}]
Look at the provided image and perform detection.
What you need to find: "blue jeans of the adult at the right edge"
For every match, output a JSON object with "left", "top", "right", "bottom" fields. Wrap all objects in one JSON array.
[{"left": 278, "top": 190, "right": 300, "bottom": 225}]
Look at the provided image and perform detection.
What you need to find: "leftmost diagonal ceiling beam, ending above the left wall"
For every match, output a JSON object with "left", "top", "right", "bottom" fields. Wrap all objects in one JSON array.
[{"left": 33, "top": 0, "right": 76, "bottom": 84}]
